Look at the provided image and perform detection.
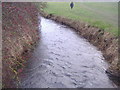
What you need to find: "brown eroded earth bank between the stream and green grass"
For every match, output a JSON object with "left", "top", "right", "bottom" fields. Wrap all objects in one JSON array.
[{"left": 40, "top": 11, "right": 120, "bottom": 85}]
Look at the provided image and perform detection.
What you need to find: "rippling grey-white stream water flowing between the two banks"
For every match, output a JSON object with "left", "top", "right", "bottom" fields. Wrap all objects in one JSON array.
[{"left": 20, "top": 18, "right": 115, "bottom": 88}]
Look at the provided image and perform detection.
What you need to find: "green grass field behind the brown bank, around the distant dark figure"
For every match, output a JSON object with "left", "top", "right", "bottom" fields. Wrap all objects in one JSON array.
[{"left": 44, "top": 2, "right": 118, "bottom": 36}]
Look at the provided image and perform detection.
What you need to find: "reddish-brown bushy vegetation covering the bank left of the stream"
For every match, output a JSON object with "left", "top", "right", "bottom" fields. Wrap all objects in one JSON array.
[{"left": 2, "top": 2, "right": 39, "bottom": 88}]
